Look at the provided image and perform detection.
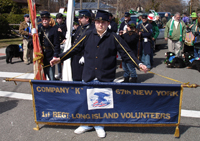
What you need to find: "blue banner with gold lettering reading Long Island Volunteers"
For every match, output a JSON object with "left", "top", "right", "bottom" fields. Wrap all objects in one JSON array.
[{"left": 31, "top": 80, "right": 182, "bottom": 126}]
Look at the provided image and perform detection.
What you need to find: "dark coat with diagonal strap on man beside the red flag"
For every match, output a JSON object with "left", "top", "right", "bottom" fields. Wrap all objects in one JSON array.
[{"left": 38, "top": 26, "right": 60, "bottom": 66}]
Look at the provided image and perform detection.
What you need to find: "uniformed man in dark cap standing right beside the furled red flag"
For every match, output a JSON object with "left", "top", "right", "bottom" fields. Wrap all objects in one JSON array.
[{"left": 38, "top": 11, "right": 60, "bottom": 80}]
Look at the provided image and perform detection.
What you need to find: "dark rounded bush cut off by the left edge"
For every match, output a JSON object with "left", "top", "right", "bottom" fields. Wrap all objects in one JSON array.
[{"left": 0, "top": 14, "right": 11, "bottom": 38}]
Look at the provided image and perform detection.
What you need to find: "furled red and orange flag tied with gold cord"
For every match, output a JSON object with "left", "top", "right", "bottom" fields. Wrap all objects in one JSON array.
[{"left": 28, "top": 0, "right": 46, "bottom": 80}]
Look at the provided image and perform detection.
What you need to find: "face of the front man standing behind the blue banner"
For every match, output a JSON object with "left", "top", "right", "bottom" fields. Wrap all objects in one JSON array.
[{"left": 95, "top": 20, "right": 110, "bottom": 34}]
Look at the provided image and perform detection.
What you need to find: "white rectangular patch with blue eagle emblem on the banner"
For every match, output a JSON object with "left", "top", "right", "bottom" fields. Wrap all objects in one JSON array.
[{"left": 87, "top": 88, "right": 114, "bottom": 110}]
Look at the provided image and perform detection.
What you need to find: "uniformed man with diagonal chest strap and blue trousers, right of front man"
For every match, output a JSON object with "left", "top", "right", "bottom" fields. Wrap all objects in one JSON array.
[{"left": 137, "top": 15, "right": 153, "bottom": 70}]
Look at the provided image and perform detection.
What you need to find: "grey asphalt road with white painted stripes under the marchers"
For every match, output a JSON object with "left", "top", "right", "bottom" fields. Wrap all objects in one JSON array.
[{"left": 0, "top": 45, "right": 200, "bottom": 141}]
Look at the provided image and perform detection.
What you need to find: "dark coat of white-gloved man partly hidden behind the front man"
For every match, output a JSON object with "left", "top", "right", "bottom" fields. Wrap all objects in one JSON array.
[{"left": 71, "top": 24, "right": 94, "bottom": 81}]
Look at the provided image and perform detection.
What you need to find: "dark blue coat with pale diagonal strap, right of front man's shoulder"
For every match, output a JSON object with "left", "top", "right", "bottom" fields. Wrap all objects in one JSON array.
[{"left": 137, "top": 22, "right": 153, "bottom": 55}]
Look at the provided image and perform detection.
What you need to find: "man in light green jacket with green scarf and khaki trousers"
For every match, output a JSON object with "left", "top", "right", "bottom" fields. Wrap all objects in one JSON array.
[{"left": 164, "top": 12, "right": 186, "bottom": 57}]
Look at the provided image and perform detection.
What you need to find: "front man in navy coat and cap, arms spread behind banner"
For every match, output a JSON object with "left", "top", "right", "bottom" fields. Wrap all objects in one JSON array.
[{"left": 50, "top": 10, "right": 147, "bottom": 137}]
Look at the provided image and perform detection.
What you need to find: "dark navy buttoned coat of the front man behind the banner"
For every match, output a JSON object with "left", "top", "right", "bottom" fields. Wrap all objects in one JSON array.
[{"left": 59, "top": 29, "right": 140, "bottom": 82}]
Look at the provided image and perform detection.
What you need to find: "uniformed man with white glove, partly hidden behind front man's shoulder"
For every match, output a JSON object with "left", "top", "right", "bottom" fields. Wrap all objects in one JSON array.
[{"left": 71, "top": 9, "right": 94, "bottom": 81}]
